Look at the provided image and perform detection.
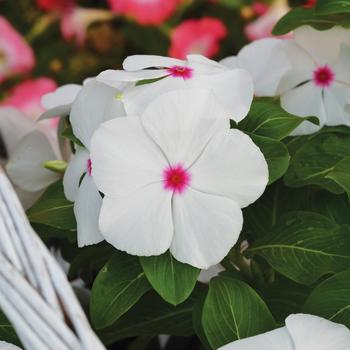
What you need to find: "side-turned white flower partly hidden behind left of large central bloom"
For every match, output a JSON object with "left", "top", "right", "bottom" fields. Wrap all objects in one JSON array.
[{"left": 63, "top": 79, "right": 125, "bottom": 247}]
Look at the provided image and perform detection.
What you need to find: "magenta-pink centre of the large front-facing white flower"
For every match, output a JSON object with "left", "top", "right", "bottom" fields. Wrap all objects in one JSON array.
[{"left": 163, "top": 164, "right": 191, "bottom": 194}]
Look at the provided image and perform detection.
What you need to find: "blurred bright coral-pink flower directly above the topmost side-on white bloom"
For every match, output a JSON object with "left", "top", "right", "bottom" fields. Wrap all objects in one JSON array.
[{"left": 169, "top": 17, "right": 227, "bottom": 59}]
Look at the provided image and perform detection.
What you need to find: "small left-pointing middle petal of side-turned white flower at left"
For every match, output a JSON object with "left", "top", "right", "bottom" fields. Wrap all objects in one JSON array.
[{"left": 63, "top": 147, "right": 90, "bottom": 202}]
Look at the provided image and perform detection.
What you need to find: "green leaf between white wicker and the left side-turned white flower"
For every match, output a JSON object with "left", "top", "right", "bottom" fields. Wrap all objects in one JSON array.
[{"left": 27, "top": 181, "right": 77, "bottom": 230}]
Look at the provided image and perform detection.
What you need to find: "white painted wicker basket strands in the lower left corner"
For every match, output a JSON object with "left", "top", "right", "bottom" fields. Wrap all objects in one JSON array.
[{"left": 0, "top": 168, "right": 105, "bottom": 350}]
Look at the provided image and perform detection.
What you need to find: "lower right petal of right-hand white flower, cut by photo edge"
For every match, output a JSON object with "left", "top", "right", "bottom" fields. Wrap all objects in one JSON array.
[{"left": 323, "top": 83, "right": 350, "bottom": 126}]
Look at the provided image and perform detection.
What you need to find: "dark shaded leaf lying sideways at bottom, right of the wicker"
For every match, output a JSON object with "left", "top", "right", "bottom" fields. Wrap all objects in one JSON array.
[{"left": 99, "top": 288, "right": 202, "bottom": 345}]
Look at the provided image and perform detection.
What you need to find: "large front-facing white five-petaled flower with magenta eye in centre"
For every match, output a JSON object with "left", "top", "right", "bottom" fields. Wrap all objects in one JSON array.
[{"left": 91, "top": 89, "right": 268, "bottom": 268}]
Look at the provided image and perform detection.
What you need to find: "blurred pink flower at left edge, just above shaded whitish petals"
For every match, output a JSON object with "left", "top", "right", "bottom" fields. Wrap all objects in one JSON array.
[{"left": 0, "top": 77, "right": 58, "bottom": 127}]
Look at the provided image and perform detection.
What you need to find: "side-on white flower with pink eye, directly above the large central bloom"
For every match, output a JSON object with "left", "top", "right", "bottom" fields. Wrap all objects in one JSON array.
[{"left": 97, "top": 55, "right": 253, "bottom": 122}]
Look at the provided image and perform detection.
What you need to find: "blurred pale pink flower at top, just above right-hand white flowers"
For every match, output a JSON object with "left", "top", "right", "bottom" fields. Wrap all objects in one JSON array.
[{"left": 244, "top": 0, "right": 289, "bottom": 41}]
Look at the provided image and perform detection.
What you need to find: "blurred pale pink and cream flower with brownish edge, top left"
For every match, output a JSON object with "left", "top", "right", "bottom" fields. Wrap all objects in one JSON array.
[{"left": 61, "top": 6, "right": 113, "bottom": 45}]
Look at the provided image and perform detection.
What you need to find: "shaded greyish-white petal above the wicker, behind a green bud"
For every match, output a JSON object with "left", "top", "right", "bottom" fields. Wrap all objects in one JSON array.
[{"left": 6, "top": 131, "right": 59, "bottom": 192}]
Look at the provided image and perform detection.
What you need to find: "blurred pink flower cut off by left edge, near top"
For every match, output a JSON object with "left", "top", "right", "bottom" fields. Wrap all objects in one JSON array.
[{"left": 0, "top": 16, "right": 35, "bottom": 82}]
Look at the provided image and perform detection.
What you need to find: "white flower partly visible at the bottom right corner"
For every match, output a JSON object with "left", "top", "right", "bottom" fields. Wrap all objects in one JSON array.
[{"left": 220, "top": 314, "right": 350, "bottom": 350}]
